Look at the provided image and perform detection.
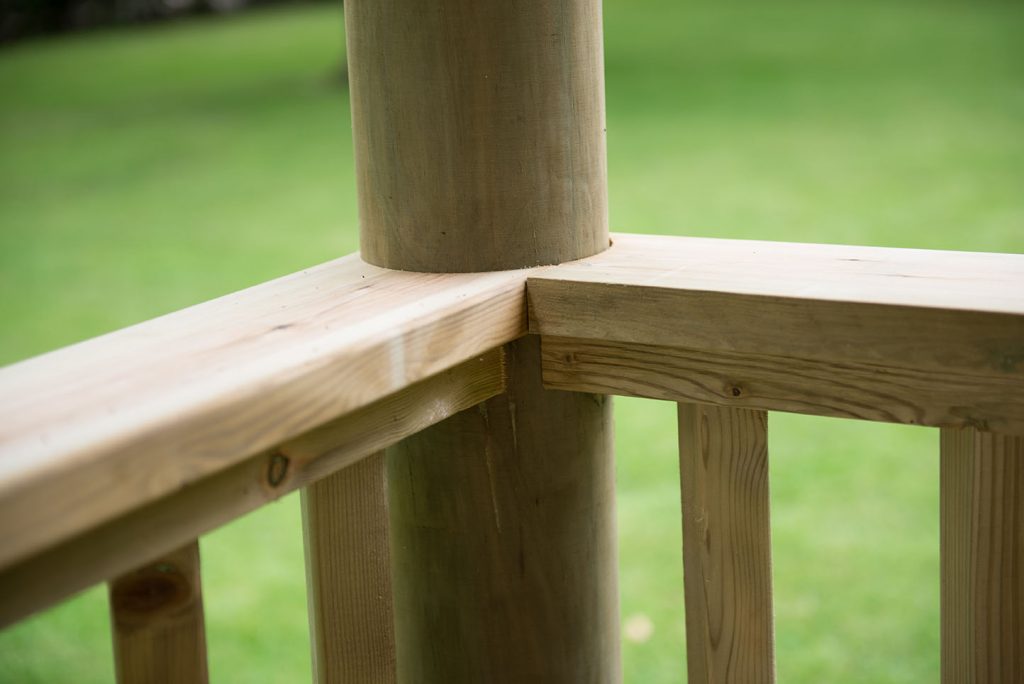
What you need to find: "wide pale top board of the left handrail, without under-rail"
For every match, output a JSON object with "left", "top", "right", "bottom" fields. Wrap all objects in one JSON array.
[{"left": 0, "top": 256, "right": 525, "bottom": 567}]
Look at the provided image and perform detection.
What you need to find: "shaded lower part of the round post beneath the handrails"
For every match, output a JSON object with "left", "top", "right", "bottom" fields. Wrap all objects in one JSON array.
[{"left": 388, "top": 338, "right": 621, "bottom": 682}]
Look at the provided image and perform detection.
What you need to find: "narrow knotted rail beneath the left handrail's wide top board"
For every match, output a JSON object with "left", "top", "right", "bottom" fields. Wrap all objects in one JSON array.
[{"left": 0, "top": 350, "right": 505, "bottom": 627}]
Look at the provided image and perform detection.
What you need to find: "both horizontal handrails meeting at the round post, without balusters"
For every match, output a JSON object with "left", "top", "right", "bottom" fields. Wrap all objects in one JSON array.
[{"left": 0, "top": 234, "right": 1024, "bottom": 624}]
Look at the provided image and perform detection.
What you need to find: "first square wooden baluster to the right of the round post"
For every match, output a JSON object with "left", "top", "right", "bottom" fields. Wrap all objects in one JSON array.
[{"left": 679, "top": 403, "right": 775, "bottom": 684}]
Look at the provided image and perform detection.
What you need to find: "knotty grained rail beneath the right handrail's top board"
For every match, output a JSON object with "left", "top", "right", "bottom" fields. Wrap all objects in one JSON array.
[{"left": 542, "top": 335, "right": 1024, "bottom": 434}]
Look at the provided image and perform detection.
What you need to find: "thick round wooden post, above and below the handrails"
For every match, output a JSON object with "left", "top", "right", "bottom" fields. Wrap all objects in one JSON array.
[{"left": 345, "top": 0, "right": 620, "bottom": 682}]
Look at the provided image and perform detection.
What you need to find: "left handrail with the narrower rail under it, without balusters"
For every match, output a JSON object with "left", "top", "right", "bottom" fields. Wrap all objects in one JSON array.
[{"left": 0, "top": 256, "right": 512, "bottom": 622}]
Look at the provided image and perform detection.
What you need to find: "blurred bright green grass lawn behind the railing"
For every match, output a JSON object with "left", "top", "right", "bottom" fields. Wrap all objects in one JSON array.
[{"left": 0, "top": 0, "right": 1024, "bottom": 684}]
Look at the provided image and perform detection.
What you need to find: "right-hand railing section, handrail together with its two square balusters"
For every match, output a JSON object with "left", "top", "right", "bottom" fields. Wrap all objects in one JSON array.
[{"left": 527, "top": 236, "right": 1024, "bottom": 682}]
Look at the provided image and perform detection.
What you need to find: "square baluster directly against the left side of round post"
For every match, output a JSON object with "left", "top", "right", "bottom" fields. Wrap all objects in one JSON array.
[{"left": 302, "top": 452, "right": 395, "bottom": 684}]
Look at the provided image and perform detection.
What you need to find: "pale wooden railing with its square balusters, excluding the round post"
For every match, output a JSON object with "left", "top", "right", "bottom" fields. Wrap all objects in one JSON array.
[{"left": 0, "top": 234, "right": 1024, "bottom": 681}]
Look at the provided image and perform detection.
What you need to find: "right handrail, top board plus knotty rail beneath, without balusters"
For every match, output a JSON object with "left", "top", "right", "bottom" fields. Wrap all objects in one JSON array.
[{"left": 527, "top": 229, "right": 1024, "bottom": 434}]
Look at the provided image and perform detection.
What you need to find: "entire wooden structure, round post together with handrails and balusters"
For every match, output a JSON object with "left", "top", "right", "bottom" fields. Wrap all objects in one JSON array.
[{"left": 0, "top": 0, "right": 1024, "bottom": 682}]
